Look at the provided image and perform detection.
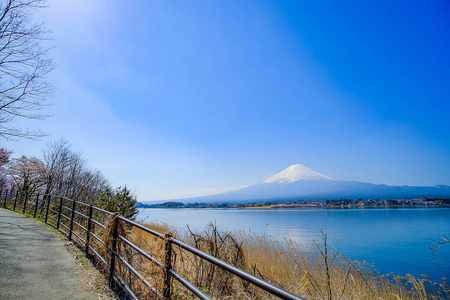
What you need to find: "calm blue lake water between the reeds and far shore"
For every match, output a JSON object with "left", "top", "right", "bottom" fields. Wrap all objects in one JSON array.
[{"left": 138, "top": 208, "right": 450, "bottom": 282}]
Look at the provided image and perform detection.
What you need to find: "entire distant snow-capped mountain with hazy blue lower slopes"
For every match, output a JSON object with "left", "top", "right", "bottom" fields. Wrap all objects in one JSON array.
[{"left": 169, "top": 164, "right": 450, "bottom": 203}]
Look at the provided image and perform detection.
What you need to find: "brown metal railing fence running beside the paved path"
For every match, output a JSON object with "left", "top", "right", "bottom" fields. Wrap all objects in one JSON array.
[{"left": 0, "top": 191, "right": 304, "bottom": 300}]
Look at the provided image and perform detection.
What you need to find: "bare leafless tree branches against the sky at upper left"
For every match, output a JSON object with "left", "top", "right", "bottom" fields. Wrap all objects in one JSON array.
[{"left": 0, "top": 0, "right": 54, "bottom": 140}]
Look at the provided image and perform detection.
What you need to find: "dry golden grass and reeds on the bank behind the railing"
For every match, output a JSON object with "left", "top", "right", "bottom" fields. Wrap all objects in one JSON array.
[{"left": 125, "top": 223, "right": 450, "bottom": 300}]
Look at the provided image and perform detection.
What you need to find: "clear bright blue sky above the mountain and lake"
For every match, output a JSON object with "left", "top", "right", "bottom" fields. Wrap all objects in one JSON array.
[{"left": 2, "top": 0, "right": 450, "bottom": 201}]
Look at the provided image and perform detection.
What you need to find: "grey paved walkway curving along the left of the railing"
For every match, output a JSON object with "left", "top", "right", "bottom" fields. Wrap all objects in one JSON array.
[{"left": 0, "top": 209, "right": 98, "bottom": 300}]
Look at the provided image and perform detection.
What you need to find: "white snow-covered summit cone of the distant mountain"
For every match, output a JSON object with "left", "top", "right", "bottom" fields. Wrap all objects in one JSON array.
[{"left": 263, "top": 164, "right": 336, "bottom": 183}]
